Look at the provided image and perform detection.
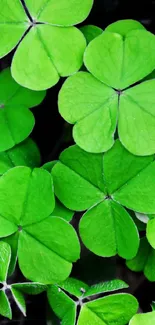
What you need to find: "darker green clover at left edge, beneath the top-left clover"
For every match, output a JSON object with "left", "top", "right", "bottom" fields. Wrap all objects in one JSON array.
[{"left": 0, "top": 67, "right": 46, "bottom": 152}]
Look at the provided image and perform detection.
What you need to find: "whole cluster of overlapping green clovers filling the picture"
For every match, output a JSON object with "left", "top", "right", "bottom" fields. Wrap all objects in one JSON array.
[{"left": 0, "top": 0, "right": 155, "bottom": 325}]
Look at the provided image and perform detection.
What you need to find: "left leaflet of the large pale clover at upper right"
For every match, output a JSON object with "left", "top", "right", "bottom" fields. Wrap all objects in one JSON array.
[{"left": 58, "top": 72, "right": 118, "bottom": 153}]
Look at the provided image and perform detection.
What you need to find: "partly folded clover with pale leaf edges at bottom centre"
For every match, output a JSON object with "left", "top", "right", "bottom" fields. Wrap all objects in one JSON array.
[{"left": 47, "top": 278, "right": 138, "bottom": 325}]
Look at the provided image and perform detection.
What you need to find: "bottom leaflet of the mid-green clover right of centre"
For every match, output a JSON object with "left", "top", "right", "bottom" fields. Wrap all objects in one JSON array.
[{"left": 79, "top": 200, "right": 139, "bottom": 258}]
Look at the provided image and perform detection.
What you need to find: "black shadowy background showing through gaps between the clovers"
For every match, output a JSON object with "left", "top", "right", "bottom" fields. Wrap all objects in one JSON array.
[{"left": 0, "top": 0, "right": 155, "bottom": 325}]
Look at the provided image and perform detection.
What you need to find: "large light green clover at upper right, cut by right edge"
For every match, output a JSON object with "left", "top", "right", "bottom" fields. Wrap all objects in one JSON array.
[{"left": 58, "top": 22, "right": 155, "bottom": 155}]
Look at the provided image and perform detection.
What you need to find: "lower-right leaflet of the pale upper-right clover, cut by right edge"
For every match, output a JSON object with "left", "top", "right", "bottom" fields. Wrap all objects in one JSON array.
[{"left": 118, "top": 79, "right": 155, "bottom": 155}]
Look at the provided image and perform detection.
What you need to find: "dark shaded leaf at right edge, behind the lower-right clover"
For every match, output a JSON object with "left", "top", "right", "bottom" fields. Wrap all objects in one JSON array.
[{"left": 126, "top": 237, "right": 155, "bottom": 282}]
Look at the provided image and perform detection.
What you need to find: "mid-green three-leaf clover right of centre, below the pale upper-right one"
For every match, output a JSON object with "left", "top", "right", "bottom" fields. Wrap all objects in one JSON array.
[{"left": 52, "top": 140, "right": 155, "bottom": 259}]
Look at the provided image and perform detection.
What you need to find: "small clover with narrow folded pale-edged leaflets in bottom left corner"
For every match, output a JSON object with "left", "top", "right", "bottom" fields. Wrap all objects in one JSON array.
[{"left": 0, "top": 242, "right": 46, "bottom": 319}]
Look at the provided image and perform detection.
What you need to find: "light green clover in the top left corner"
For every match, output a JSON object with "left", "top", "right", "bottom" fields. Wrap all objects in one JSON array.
[{"left": 0, "top": 0, "right": 93, "bottom": 90}]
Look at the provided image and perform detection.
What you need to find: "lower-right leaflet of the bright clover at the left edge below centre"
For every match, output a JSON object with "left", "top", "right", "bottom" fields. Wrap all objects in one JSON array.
[{"left": 18, "top": 217, "right": 80, "bottom": 284}]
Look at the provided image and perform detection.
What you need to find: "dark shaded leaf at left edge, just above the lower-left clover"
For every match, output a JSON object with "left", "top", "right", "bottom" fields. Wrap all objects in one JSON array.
[{"left": 0, "top": 138, "right": 40, "bottom": 176}]
